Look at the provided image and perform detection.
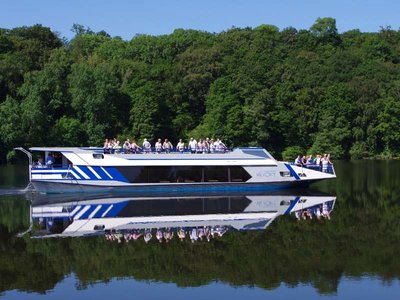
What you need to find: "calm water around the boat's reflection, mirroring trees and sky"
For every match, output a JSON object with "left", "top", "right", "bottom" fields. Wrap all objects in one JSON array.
[{"left": 0, "top": 161, "right": 400, "bottom": 299}]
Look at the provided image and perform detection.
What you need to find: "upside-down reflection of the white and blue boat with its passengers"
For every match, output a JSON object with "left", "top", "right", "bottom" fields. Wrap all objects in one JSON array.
[{"left": 32, "top": 190, "right": 336, "bottom": 242}]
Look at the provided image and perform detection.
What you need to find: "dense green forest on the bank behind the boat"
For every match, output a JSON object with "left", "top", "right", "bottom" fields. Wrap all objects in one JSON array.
[{"left": 0, "top": 18, "right": 400, "bottom": 162}]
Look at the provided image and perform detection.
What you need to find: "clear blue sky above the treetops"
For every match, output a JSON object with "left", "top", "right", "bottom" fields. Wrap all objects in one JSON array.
[{"left": 0, "top": 0, "right": 400, "bottom": 40}]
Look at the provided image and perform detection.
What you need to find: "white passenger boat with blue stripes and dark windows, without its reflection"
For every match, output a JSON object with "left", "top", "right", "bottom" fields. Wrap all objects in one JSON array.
[{"left": 16, "top": 147, "right": 336, "bottom": 193}]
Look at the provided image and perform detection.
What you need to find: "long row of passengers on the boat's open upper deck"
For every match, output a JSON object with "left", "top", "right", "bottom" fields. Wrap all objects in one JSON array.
[{"left": 103, "top": 138, "right": 228, "bottom": 154}]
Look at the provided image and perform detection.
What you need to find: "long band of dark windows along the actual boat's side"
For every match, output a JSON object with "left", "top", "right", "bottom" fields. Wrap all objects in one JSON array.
[{"left": 117, "top": 166, "right": 251, "bottom": 183}]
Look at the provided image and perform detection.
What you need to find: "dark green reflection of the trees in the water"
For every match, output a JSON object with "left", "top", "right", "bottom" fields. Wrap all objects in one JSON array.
[{"left": 0, "top": 162, "right": 400, "bottom": 294}]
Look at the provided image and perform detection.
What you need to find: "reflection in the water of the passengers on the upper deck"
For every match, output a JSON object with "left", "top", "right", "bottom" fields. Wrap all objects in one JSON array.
[{"left": 105, "top": 226, "right": 228, "bottom": 243}]
